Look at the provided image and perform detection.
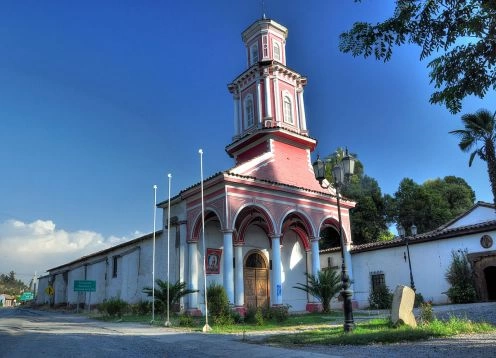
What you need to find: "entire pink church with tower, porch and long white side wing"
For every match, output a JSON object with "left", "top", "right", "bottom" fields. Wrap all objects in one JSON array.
[{"left": 38, "top": 18, "right": 354, "bottom": 314}]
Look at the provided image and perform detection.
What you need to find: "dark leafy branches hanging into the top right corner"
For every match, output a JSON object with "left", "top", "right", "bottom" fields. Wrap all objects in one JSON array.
[{"left": 339, "top": 0, "right": 496, "bottom": 113}]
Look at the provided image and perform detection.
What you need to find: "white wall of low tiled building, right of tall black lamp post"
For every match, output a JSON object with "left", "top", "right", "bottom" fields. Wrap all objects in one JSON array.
[{"left": 352, "top": 231, "right": 496, "bottom": 307}]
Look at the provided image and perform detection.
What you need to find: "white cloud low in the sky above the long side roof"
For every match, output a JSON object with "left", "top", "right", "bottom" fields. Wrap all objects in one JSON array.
[{"left": 0, "top": 220, "right": 130, "bottom": 282}]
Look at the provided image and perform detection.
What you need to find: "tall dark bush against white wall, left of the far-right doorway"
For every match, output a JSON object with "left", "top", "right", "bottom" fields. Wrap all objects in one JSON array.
[{"left": 443, "top": 250, "right": 477, "bottom": 303}]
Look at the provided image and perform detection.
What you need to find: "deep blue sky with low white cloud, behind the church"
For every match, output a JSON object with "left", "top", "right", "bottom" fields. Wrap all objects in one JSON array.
[{"left": 0, "top": 0, "right": 496, "bottom": 279}]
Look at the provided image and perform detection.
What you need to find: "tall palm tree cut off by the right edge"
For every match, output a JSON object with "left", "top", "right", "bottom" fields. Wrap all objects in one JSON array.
[{"left": 450, "top": 109, "right": 496, "bottom": 205}]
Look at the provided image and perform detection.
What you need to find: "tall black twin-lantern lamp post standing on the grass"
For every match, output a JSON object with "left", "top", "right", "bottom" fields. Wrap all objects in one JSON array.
[{"left": 313, "top": 150, "right": 355, "bottom": 332}]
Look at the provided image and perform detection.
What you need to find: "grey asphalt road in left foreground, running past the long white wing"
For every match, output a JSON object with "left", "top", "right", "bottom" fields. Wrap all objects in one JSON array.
[{"left": 0, "top": 308, "right": 338, "bottom": 358}]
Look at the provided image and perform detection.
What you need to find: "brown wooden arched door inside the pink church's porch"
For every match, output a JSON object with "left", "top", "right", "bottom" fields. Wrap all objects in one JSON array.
[{"left": 244, "top": 251, "right": 270, "bottom": 307}]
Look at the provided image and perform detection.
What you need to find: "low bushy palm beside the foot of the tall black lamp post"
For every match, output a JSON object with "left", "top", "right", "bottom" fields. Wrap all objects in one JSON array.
[{"left": 293, "top": 268, "right": 341, "bottom": 313}]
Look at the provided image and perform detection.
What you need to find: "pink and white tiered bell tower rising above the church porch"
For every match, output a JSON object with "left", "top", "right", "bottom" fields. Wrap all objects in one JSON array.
[{"left": 226, "top": 18, "right": 316, "bottom": 188}]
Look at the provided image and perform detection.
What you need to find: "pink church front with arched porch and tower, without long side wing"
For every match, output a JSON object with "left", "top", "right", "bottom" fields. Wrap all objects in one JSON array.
[{"left": 159, "top": 19, "right": 354, "bottom": 312}]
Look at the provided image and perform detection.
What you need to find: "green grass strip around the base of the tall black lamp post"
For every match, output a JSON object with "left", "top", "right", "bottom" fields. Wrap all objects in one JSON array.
[{"left": 265, "top": 317, "right": 496, "bottom": 346}]
